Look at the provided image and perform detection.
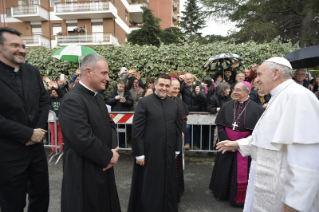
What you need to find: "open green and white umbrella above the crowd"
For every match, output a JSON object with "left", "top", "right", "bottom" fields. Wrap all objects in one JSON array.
[{"left": 51, "top": 45, "right": 97, "bottom": 64}]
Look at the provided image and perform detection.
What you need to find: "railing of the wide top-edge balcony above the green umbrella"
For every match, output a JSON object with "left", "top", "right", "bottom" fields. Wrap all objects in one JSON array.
[{"left": 55, "top": 2, "right": 110, "bottom": 13}]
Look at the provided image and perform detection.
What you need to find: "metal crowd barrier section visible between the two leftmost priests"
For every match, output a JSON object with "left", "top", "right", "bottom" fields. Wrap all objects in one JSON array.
[{"left": 44, "top": 110, "right": 63, "bottom": 165}]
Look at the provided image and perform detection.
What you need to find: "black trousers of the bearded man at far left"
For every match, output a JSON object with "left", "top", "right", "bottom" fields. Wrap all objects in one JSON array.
[{"left": 0, "top": 148, "right": 49, "bottom": 212}]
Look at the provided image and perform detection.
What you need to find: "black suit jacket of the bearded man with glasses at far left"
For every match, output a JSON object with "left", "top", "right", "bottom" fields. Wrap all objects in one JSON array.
[{"left": 0, "top": 62, "right": 50, "bottom": 162}]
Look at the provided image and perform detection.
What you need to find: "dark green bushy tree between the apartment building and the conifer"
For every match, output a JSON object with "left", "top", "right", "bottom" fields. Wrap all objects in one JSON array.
[{"left": 127, "top": 7, "right": 162, "bottom": 46}]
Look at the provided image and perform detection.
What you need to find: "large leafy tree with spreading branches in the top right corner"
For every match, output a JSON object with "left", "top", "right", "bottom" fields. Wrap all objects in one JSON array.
[{"left": 201, "top": 0, "right": 319, "bottom": 47}]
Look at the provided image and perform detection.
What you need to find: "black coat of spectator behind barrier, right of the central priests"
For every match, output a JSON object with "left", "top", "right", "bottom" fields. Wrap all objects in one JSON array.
[{"left": 180, "top": 82, "right": 206, "bottom": 112}]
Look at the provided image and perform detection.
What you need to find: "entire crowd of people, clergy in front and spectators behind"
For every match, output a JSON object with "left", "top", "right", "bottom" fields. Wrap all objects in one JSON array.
[{"left": 0, "top": 27, "right": 319, "bottom": 212}]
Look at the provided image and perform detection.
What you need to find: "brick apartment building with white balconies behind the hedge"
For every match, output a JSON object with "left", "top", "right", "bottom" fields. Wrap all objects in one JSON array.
[{"left": 0, "top": 0, "right": 178, "bottom": 48}]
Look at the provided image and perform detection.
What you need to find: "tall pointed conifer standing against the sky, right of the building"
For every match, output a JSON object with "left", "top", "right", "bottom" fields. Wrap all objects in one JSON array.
[{"left": 179, "top": 0, "right": 205, "bottom": 37}]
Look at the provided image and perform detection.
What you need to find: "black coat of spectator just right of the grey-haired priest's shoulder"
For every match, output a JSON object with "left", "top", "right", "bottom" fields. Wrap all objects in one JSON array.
[{"left": 106, "top": 87, "right": 133, "bottom": 111}]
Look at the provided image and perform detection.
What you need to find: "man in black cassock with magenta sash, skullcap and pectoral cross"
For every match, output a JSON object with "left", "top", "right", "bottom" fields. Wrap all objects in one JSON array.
[{"left": 209, "top": 81, "right": 264, "bottom": 206}]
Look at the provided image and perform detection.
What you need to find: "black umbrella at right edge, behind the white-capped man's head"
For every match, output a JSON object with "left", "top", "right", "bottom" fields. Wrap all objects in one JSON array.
[{"left": 285, "top": 46, "right": 319, "bottom": 69}]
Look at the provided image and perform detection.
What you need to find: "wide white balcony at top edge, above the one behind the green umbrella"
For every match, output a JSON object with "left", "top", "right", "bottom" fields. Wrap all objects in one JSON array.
[{"left": 54, "top": 1, "right": 117, "bottom": 20}]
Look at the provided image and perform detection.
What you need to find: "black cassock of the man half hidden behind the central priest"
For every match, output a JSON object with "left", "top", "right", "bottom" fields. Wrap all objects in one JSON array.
[{"left": 173, "top": 97, "right": 189, "bottom": 197}]
